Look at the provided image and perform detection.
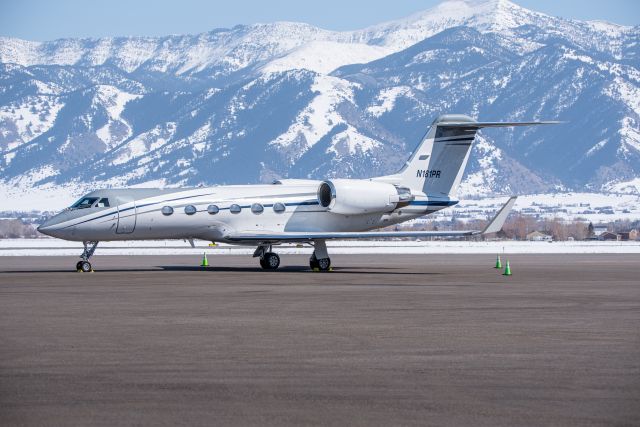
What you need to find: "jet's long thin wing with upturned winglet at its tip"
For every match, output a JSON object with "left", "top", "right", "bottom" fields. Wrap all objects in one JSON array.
[{"left": 225, "top": 196, "right": 517, "bottom": 242}]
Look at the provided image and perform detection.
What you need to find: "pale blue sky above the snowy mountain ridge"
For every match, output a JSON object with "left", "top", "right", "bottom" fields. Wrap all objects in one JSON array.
[{"left": 0, "top": 0, "right": 640, "bottom": 40}]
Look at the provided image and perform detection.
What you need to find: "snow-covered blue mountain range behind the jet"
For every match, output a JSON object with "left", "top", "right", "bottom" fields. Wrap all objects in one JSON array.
[{"left": 0, "top": 0, "right": 640, "bottom": 209}]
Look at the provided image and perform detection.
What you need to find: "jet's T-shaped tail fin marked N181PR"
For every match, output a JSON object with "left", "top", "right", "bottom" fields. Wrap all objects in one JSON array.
[{"left": 376, "top": 114, "right": 560, "bottom": 199}]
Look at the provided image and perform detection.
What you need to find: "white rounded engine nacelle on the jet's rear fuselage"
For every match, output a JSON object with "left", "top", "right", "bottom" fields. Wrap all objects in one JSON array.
[{"left": 318, "top": 179, "right": 413, "bottom": 215}]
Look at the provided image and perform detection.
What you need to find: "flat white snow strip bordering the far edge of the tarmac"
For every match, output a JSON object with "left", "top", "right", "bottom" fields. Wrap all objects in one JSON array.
[{"left": 0, "top": 239, "right": 640, "bottom": 256}]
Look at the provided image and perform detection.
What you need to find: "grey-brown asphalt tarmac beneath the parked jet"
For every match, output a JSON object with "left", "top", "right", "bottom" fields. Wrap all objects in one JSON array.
[{"left": 0, "top": 255, "right": 640, "bottom": 426}]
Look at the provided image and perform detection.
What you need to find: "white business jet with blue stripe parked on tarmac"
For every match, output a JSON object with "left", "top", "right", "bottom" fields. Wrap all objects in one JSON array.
[{"left": 38, "top": 114, "right": 558, "bottom": 272}]
